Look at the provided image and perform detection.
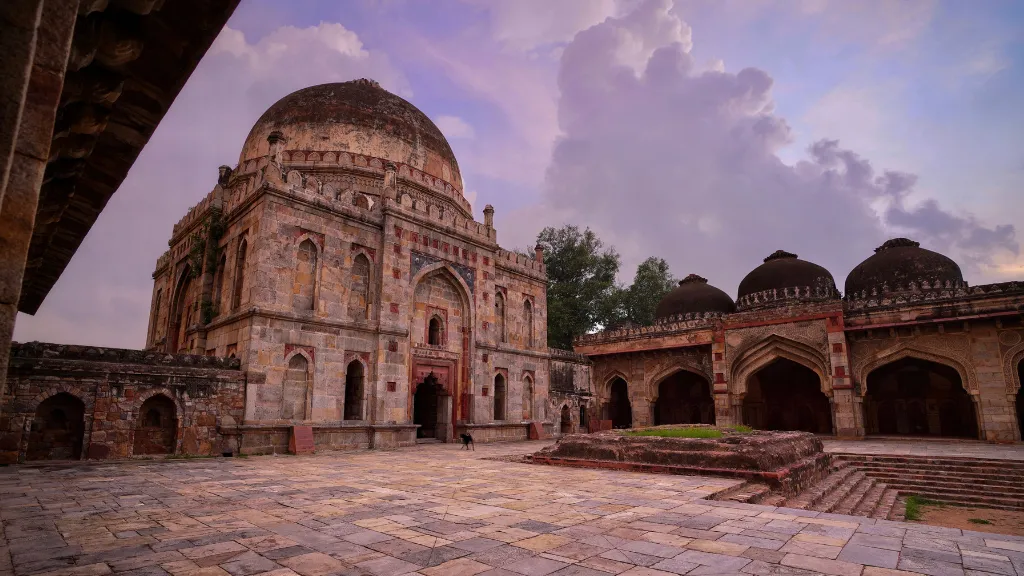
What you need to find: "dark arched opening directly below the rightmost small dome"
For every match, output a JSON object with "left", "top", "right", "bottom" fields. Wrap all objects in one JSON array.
[{"left": 864, "top": 358, "right": 978, "bottom": 438}]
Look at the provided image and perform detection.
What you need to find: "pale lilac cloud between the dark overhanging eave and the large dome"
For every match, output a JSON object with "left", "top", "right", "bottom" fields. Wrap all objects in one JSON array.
[{"left": 14, "top": 23, "right": 411, "bottom": 347}]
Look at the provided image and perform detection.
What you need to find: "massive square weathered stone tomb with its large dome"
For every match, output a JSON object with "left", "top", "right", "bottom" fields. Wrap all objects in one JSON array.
[{"left": 146, "top": 80, "right": 589, "bottom": 452}]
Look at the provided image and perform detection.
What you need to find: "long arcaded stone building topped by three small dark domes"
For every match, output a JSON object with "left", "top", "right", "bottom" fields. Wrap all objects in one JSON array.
[{"left": 574, "top": 243, "right": 1024, "bottom": 442}]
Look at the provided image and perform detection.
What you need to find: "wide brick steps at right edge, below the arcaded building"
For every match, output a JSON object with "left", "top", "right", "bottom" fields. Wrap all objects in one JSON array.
[{"left": 833, "top": 454, "right": 1024, "bottom": 510}]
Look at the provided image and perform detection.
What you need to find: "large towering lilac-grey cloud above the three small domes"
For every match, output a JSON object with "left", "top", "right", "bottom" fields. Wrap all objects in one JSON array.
[{"left": 530, "top": 0, "right": 1017, "bottom": 291}]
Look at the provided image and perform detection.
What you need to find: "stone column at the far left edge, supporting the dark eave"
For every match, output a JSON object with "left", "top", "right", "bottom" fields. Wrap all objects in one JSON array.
[{"left": 0, "top": 0, "right": 78, "bottom": 407}]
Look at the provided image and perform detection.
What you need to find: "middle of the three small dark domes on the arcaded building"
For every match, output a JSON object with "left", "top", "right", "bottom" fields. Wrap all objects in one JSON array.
[{"left": 736, "top": 250, "right": 839, "bottom": 308}]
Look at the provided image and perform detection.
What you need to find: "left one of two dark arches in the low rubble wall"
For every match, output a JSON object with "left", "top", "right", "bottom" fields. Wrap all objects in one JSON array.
[{"left": 26, "top": 392, "right": 85, "bottom": 460}]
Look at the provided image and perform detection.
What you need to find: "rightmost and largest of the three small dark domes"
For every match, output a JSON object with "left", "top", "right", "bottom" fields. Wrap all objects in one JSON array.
[{"left": 846, "top": 238, "right": 966, "bottom": 297}]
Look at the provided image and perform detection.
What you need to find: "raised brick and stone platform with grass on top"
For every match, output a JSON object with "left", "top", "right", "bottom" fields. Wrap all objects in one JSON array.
[{"left": 531, "top": 426, "right": 830, "bottom": 495}]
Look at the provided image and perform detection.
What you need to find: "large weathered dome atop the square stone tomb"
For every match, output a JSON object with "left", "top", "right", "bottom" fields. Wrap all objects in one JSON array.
[{"left": 239, "top": 79, "right": 463, "bottom": 194}]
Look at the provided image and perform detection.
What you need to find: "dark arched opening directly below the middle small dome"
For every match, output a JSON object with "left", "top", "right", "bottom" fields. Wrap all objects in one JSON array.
[{"left": 743, "top": 358, "right": 833, "bottom": 434}]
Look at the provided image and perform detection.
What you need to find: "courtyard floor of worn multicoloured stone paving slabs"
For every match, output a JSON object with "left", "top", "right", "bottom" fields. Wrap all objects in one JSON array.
[{"left": 0, "top": 442, "right": 1024, "bottom": 576}]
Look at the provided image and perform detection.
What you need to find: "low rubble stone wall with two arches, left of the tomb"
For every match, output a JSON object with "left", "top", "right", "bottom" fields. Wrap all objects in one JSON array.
[{"left": 0, "top": 342, "right": 245, "bottom": 463}]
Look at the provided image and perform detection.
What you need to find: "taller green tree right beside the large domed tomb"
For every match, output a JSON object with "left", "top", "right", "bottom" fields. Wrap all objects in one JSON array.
[{"left": 537, "top": 225, "right": 618, "bottom": 349}]
